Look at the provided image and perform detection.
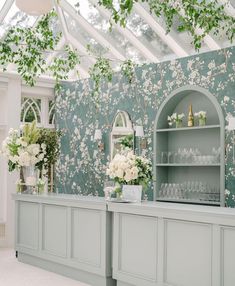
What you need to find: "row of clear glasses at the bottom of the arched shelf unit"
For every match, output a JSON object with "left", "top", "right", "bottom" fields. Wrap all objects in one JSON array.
[{"left": 159, "top": 182, "right": 220, "bottom": 202}]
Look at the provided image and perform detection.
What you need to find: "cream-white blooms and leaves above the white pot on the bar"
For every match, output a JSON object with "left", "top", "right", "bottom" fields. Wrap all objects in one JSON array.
[{"left": 106, "top": 151, "right": 152, "bottom": 185}]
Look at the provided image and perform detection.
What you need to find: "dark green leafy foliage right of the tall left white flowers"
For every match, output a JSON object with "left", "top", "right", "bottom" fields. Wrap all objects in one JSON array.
[{"left": 37, "top": 128, "right": 62, "bottom": 169}]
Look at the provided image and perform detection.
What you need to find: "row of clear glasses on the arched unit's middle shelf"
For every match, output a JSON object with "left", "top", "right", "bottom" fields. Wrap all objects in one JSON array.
[{"left": 161, "top": 147, "right": 220, "bottom": 165}]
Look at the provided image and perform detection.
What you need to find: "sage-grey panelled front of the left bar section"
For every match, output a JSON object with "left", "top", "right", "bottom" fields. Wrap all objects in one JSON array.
[{"left": 16, "top": 200, "right": 113, "bottom": 286}]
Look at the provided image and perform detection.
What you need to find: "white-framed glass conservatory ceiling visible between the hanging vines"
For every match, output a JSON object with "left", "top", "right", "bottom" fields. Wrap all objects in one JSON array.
[{"left": 0, "top": 0, "right": 235, "bottom": 80}]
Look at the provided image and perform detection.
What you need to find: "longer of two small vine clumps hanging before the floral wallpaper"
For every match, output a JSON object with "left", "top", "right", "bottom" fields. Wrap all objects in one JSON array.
[{"left": 89, "top": 56, "right": 113, "bottom": 97}]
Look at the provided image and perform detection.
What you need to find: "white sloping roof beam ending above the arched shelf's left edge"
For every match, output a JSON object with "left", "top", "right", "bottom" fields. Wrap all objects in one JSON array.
[{"left": 89, "top": 0, "right": 159, "bottom": 63}]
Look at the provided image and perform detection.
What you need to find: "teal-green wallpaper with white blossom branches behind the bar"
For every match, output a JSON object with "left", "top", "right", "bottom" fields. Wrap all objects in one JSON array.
[{"left": 56, "top": 47, "right": 235, "bottom": 207}]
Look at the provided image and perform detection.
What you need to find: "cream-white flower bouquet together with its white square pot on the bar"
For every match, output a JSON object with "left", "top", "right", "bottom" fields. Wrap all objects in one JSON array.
[{"left": 107, "top": 151, "right": 152, "bottom": 202}]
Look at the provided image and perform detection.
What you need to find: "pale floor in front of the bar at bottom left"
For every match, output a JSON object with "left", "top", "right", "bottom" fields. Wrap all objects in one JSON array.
[{"left": 0, "top": 248, "right": 89, "bottom": 286}]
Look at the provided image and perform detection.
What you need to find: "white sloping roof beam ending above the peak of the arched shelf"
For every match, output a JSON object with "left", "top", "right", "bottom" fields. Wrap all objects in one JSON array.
[{"left": 134, "top": 3, "right": 189, "bottom": 57}]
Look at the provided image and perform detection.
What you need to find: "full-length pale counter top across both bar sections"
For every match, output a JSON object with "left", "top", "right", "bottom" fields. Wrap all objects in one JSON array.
[{"left": 12, "top": 194, "right": 235, "bottom": 226}]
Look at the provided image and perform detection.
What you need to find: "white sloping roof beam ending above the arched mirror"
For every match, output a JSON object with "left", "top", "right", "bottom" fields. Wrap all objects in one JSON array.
[{"left": 59, "top": 0, "right": 126, "bottom": 61}]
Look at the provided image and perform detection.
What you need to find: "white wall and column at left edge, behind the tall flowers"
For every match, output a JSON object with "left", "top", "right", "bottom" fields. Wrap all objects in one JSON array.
[{"left": 0, "top": 73, "right": 54, "bottom": 247}]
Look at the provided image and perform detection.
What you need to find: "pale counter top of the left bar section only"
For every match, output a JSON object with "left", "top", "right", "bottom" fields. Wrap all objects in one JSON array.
[{"left": 12, "top": 193, "right": 107, "bottom": 210}]
